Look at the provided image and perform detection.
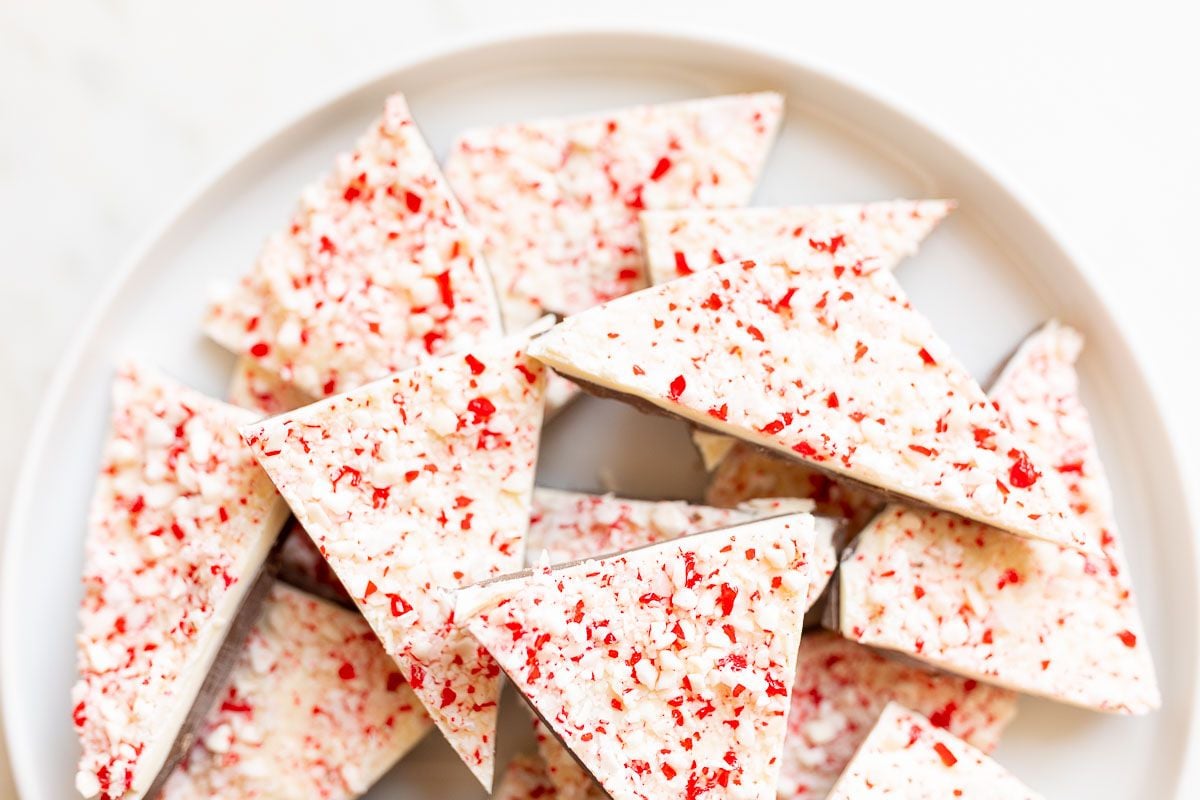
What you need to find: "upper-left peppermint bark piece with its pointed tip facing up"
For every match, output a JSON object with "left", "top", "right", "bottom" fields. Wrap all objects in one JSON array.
[{"left": 205, "top": 95, "right": 499, "bottom": 397}]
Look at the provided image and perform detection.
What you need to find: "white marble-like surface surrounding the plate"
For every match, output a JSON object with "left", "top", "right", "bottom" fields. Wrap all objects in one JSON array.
[{"left": 0, "top": 0, "right": 1200, "bottom": 798}]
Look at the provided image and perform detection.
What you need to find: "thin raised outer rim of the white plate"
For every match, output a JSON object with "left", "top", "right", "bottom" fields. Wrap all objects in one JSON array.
[{"left": 0, "top": 23, "right": 1200, "bottom": 800}]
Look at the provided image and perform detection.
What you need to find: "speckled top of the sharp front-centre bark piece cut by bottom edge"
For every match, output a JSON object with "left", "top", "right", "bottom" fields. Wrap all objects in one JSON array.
[{"left": 457, "top": 515, "right": 814, "bottom": 800}]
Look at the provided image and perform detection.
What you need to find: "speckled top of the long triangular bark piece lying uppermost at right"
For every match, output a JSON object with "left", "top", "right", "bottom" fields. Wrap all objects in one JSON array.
[{"left": 529, "top": 256, "right": 1091, "bottom": 547}]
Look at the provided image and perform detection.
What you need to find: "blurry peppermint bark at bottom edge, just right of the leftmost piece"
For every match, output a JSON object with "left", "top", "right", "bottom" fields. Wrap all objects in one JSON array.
[{"left": 163, "top": 584, "right": 433, "bottom": 800}]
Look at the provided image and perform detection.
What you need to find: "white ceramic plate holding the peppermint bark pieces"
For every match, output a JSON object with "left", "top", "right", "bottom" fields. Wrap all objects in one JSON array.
[{"left": 0, "top": 26, "right": 1198, "bottom": 800}]
